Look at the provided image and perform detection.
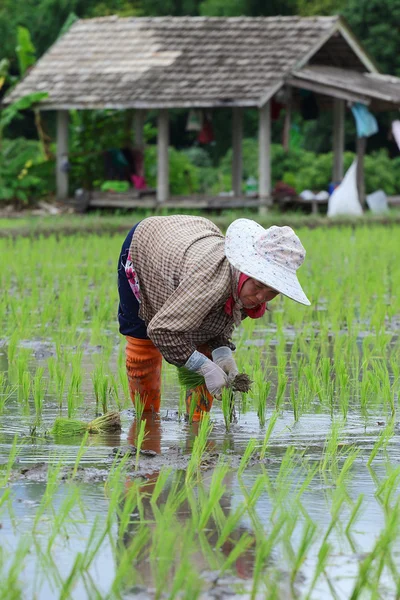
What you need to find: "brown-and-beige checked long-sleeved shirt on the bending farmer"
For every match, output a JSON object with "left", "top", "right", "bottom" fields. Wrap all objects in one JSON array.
[{"left": 130, "top": 215, "right": 246, "bottom": 366}]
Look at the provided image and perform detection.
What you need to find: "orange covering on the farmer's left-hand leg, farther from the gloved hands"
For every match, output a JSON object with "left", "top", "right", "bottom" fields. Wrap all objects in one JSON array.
[{"left": 126, "top": 335, "right": 162, "bottom": 413}]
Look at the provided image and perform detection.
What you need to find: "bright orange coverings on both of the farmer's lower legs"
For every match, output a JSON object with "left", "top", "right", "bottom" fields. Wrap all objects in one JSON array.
[{"left": 126, "top": 336, "right": 213, "bottom": 421}]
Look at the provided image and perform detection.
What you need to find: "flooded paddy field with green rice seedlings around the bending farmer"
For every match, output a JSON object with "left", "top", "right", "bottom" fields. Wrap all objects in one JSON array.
[{"left": 0, "top": 224, "right": 400, "bottom": 600}]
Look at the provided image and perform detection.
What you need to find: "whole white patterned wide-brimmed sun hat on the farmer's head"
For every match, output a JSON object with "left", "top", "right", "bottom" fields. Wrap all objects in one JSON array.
[{"left": 225, "top": 219, "right": 311, "bottom": 306}]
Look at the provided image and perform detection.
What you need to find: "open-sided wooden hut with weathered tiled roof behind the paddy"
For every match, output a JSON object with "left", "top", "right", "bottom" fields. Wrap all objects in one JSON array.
[{"left": 7, "top": 16, "right": 400, "bottom": 209}]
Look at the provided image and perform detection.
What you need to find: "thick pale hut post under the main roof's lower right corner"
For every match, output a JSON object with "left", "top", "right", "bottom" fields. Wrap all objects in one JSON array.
[{"left": 258, "top": 102, "right": 272, "bottom": 214}]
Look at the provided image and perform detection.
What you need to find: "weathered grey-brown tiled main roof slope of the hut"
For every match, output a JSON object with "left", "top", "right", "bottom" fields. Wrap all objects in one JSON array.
[{"left": 7, "top": 17, "right": 339, "bottom": 109}]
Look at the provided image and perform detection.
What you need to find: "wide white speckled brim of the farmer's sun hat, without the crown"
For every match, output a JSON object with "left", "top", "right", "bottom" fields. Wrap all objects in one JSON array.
[{"left": 225, "top": 219, "right": 311, "bottom": 306}]
